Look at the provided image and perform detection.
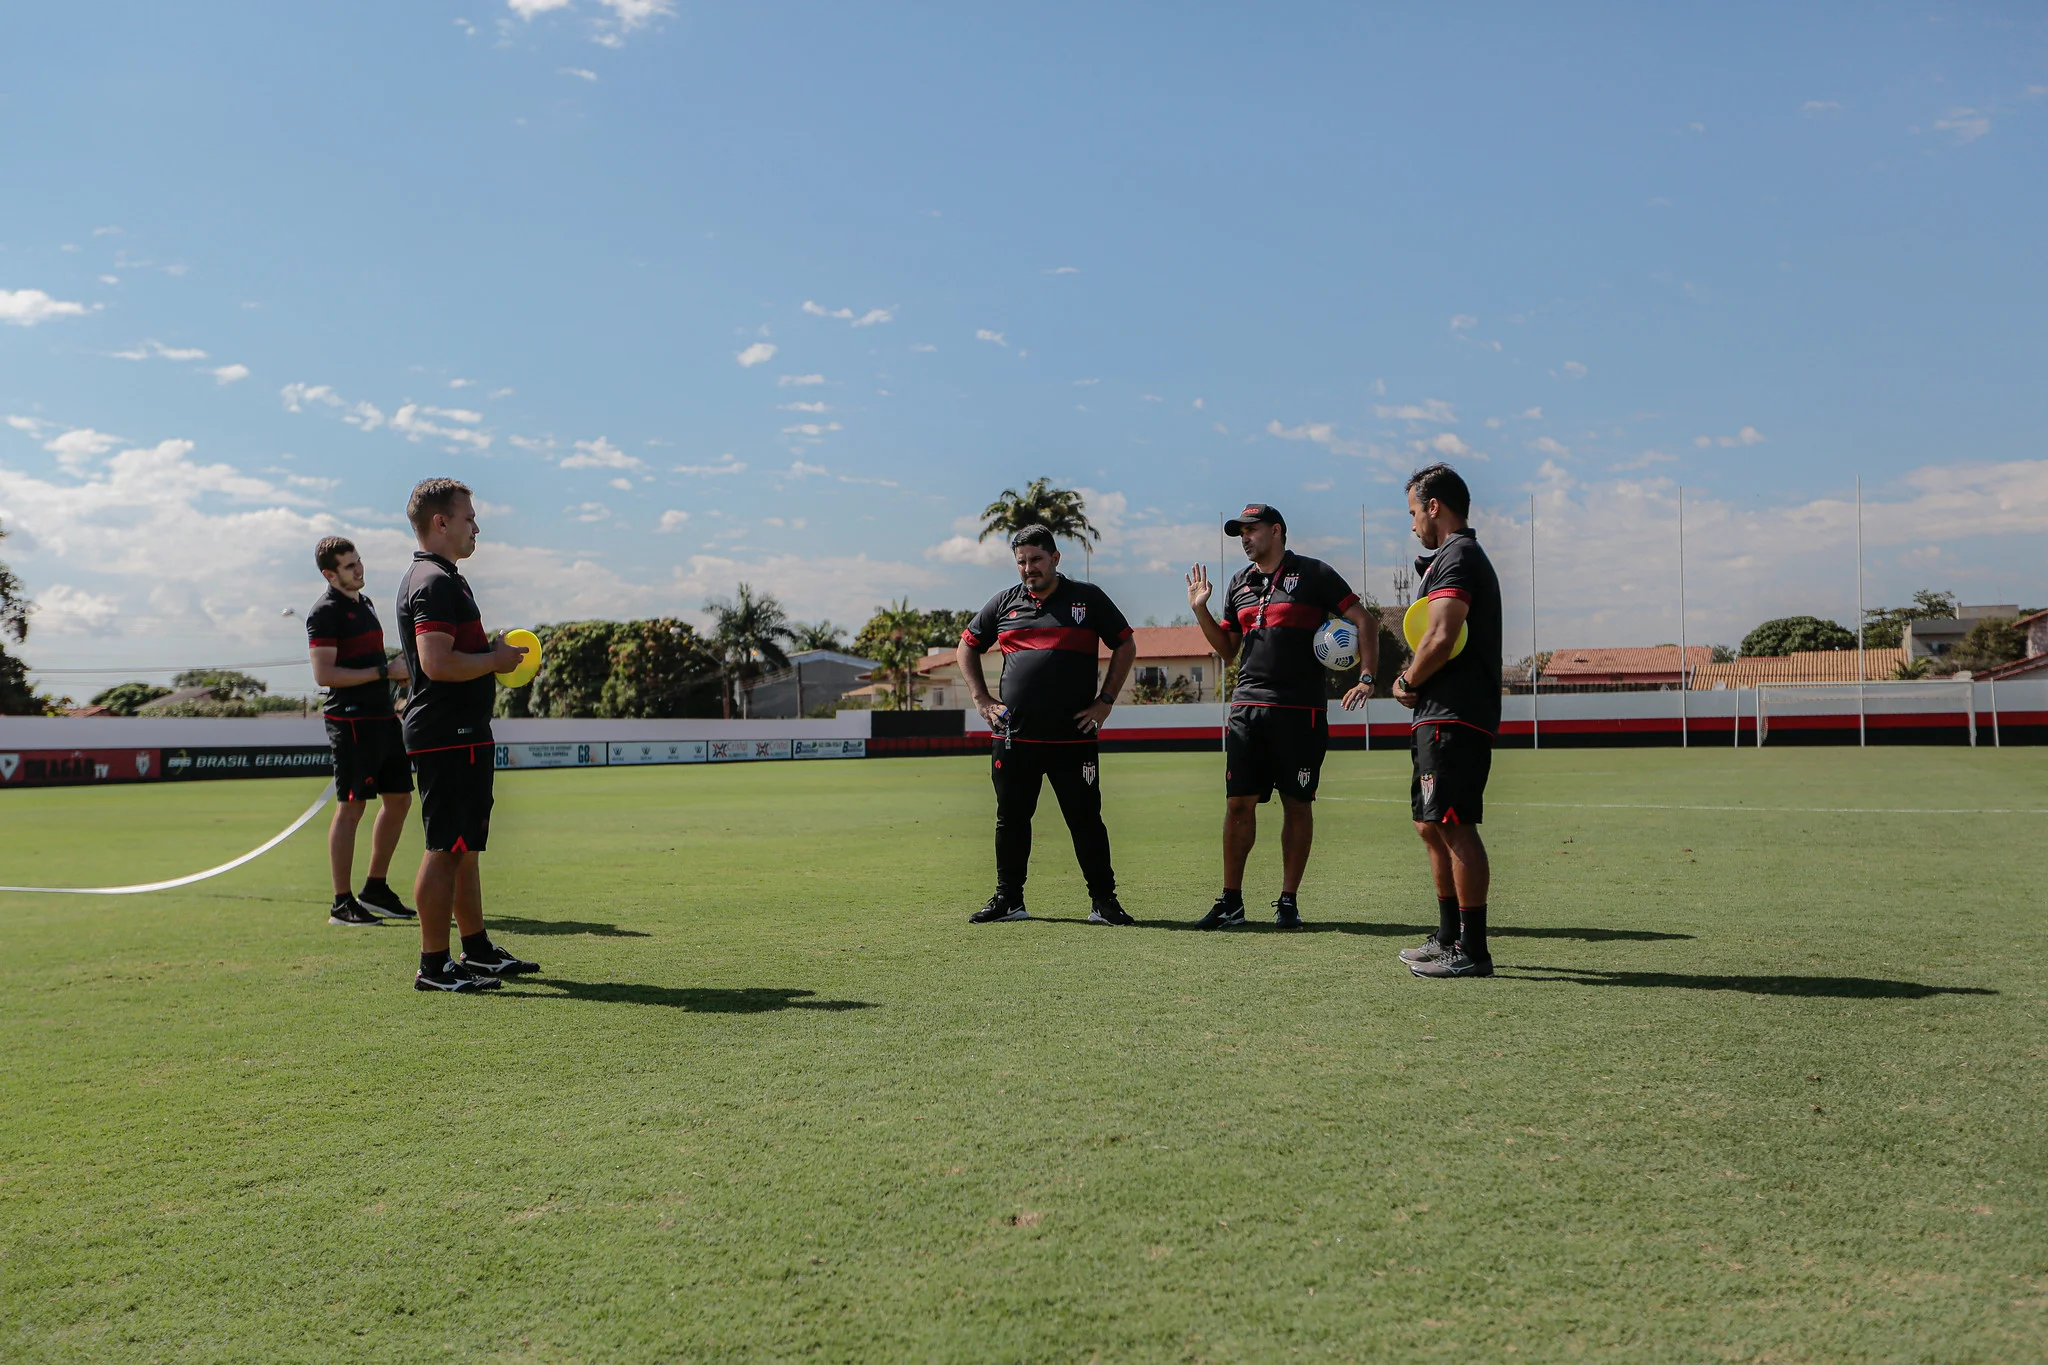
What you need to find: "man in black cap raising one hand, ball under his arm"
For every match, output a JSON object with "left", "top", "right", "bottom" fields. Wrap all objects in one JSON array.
[{"left": 1188, "top": 503, "right": 1380, "bottom": 929}]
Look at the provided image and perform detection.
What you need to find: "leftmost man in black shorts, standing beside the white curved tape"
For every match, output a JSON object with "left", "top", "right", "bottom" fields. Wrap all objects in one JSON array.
[{"left": 305, "top": 536, "right": 412, "bottom": 925}]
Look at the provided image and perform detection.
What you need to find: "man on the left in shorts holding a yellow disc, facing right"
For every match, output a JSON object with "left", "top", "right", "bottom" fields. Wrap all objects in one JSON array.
[{"left": 397, "top": 479, "right": 541, "bottom": 990}]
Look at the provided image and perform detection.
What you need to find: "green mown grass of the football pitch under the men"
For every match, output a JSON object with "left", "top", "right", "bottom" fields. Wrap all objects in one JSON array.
[{"left": 0, "top": 749, "right": 2048, "bottom": 1361}]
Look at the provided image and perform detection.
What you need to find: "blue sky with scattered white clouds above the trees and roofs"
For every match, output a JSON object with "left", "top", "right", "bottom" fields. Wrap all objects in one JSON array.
[{"left": 0, "top": 0, "right": 2048, "bottom": 692}]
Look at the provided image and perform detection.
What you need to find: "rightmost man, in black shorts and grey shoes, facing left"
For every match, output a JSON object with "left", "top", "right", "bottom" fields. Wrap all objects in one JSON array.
[{"left": 1395, "top": 465, "right": 1501, "bottom": 976}]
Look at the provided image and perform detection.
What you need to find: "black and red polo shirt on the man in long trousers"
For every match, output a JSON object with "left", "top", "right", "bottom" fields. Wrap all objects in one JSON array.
[{"left": 961, "top": 577, "right": 1130, "bottom": 743}]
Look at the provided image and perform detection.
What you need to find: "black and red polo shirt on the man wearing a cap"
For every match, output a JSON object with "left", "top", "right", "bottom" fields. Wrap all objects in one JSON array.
[{"left": 1221, "top": 551, "right": 1358, "bottom": 710}]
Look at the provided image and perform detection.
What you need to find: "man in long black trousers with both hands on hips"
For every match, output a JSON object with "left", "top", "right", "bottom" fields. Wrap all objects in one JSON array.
[{"left": 954, "top": 526, "right": 1139, "bottom": 925}]
